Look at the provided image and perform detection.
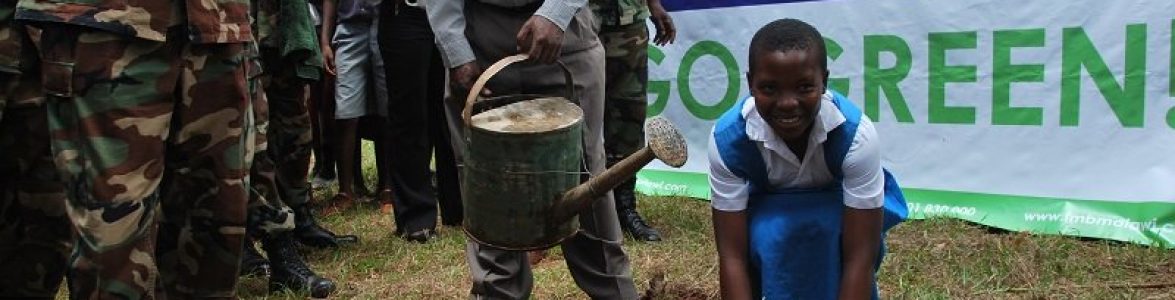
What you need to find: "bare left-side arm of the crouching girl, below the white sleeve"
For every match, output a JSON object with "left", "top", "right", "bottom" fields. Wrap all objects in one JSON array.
[{"left": 712, "top": 209, "right": 751, "bottom": 300}]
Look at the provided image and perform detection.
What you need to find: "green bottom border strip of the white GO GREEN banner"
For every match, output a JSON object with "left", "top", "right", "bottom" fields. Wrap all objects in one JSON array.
[{"left": 637, "top": 169, "right": 1175, "bottom": 248}]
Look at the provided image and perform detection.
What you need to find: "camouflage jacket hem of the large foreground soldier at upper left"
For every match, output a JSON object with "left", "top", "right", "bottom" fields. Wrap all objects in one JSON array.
[{"left": 16, "top": 0, "right": 253, "bottom": 44}]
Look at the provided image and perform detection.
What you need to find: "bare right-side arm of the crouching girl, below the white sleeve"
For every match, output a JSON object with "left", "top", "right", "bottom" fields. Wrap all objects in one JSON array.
[{"left": 838, "top": 207, "right": 882, "bottom": 300}]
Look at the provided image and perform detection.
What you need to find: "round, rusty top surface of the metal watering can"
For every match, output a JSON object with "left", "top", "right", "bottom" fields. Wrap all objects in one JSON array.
[{"left": 471, "top": 96, "right": 584, "bottom": 133}]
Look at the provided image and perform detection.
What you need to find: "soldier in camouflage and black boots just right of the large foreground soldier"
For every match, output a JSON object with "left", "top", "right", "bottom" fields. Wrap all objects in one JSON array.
[{"left": 242, "top": 0, "right": 335, "bottom": 298}]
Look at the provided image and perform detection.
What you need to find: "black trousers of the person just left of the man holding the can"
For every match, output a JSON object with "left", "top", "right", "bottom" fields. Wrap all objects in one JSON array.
[{"left": 378, "top": 1, "right": 446, "bottom": 233}]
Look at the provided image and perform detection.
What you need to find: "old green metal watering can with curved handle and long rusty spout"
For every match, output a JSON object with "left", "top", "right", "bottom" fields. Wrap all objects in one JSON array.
[{"left": 461, "top": 55, "right": 687, "bottom": 251}]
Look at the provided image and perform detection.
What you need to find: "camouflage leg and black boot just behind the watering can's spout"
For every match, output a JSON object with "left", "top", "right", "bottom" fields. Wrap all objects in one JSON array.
[{"left": 599, "top": 22, "right": 660, "bottom": 241}]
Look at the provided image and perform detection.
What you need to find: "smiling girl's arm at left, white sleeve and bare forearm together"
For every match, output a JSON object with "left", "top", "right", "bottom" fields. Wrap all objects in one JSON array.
[{"left": 707, "top": 134, "right": 751, "bottom": 299}]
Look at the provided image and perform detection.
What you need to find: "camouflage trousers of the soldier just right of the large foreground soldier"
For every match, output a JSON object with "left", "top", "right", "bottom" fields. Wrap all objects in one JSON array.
[{"left": 248, "top": 49, "right": 311, "bottom": 236}]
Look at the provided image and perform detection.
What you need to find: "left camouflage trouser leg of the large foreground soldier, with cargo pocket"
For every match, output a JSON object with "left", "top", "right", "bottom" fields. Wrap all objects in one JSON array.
[{"left": 29, "top": 24, "right": 179, "bottom": 299}]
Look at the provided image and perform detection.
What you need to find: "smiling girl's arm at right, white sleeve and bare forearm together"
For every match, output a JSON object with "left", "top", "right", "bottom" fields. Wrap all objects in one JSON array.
[{"left": 839, "top": 115, "right": 885, "bottom": 299}]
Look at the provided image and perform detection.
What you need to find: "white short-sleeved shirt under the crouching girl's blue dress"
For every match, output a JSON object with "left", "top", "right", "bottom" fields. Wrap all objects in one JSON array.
[{"left": 709, "top": 93, "right": 885, "bottom": 212}]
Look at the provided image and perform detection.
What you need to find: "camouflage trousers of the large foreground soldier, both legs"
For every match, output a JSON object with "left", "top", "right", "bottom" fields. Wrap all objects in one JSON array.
[{"left": 29, "top": 24, "right": 250, "bottom": 299}]
